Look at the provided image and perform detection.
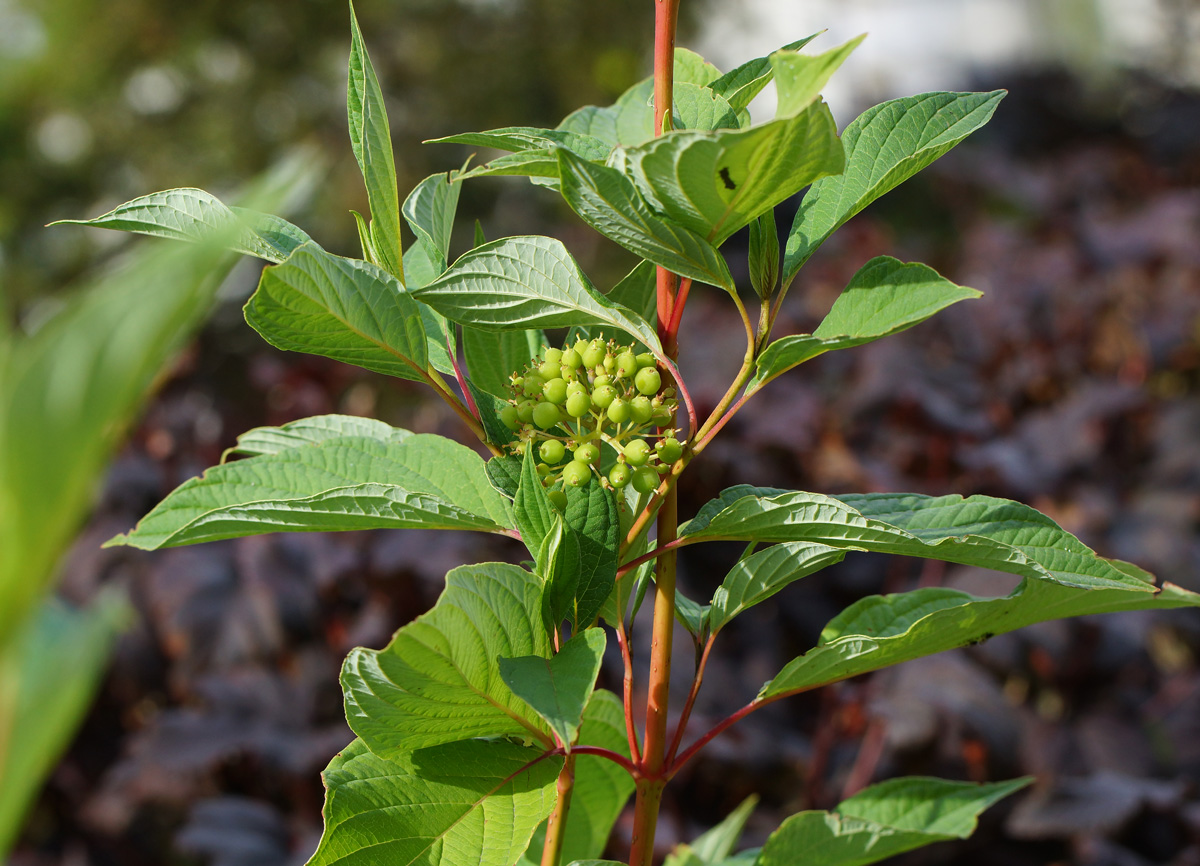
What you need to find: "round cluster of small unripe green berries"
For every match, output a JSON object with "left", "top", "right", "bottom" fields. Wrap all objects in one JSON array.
[{"left": 500, "top": 338, "right": 683, "bottom": 507}]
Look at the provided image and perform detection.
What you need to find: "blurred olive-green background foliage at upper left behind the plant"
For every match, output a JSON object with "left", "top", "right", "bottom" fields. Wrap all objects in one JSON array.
[{"left": 0, "top": 0, "right": 686, "bottom": 321}]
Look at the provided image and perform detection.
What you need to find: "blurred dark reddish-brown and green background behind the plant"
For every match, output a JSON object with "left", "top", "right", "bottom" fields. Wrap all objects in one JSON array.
[{"left": 0, "top": 0, "right": 1200, "bottom": 866}]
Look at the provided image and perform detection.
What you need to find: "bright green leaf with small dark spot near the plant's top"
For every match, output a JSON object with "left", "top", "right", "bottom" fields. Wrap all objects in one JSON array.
[{"left": 619, "top": 102, "right": 844, "bottom": 244}]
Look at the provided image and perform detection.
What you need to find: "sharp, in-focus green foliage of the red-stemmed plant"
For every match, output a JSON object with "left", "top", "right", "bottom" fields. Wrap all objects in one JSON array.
[{"left": 63, "top": 10, "right": 1200, "bottom": 866}]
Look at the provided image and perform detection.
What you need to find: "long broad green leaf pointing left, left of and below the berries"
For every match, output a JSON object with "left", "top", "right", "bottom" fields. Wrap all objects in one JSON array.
[{"left": 108, "top": 434, "right": 512, "bottom": 551}]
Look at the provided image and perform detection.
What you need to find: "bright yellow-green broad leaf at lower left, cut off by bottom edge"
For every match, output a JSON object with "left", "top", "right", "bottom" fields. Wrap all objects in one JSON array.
[{"left": 308, "top": 740, "right": 563, "bottom": 866}]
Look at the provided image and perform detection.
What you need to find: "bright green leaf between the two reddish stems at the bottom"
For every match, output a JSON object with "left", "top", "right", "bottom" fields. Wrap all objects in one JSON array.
[{"left": 521, "top": 688, "right": 634, "bottom": 864}]
